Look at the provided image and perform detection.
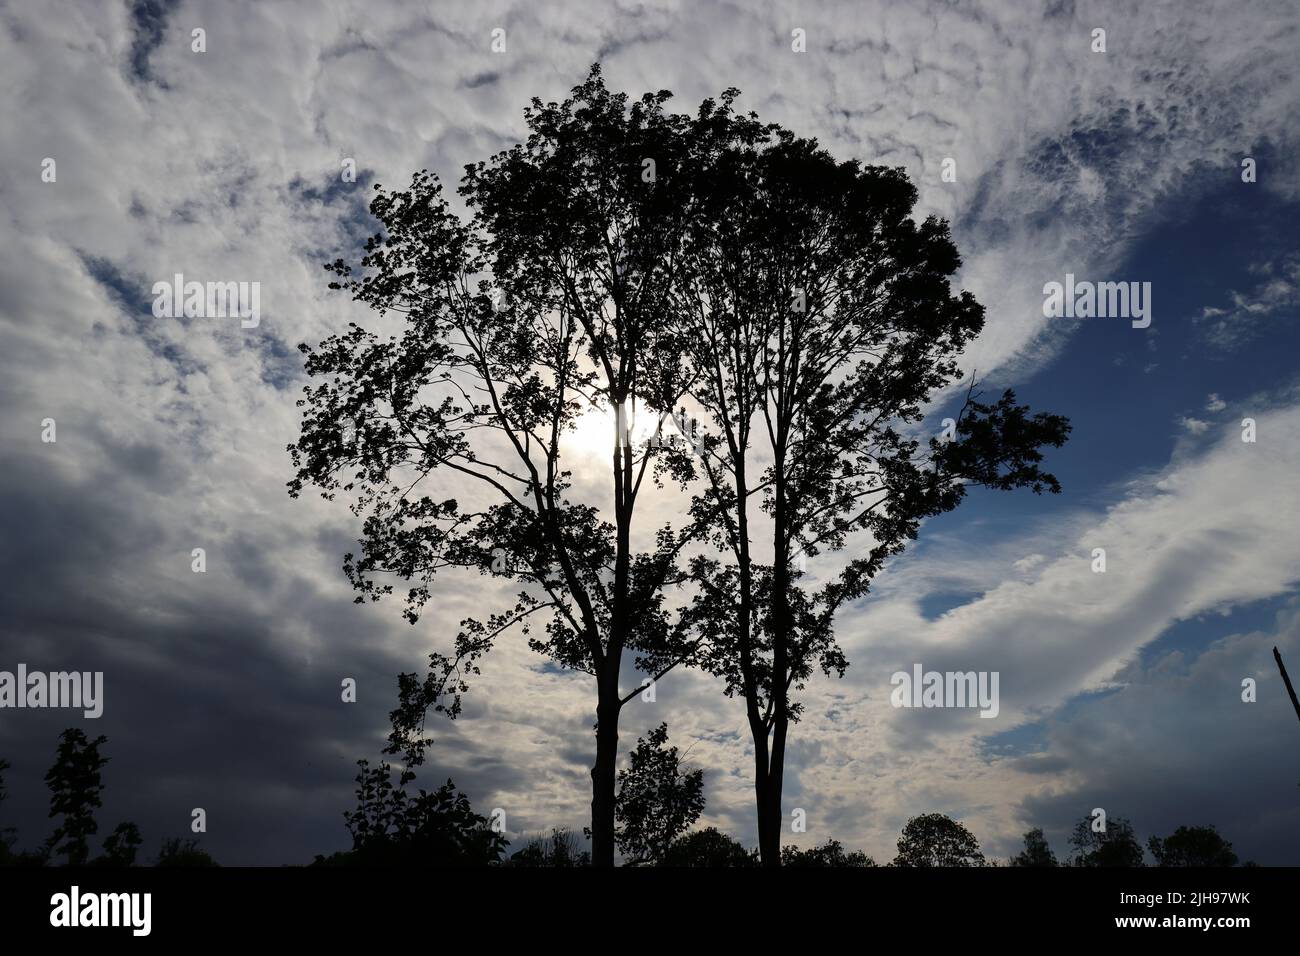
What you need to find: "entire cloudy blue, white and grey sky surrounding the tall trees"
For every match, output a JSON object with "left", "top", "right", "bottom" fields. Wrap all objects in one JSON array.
[{"left": 0, "top": 0, "right": 1300, "bottom": 864}]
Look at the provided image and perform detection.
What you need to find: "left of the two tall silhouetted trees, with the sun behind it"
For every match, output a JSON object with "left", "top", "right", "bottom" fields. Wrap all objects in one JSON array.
[{"left": 290, "top": 68, "right": 748, "bottom": 866}]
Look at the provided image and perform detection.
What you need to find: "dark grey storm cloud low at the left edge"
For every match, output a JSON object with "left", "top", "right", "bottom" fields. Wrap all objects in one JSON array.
[{"left": 0, "top": 434, "right": 398, "bottom": 864}]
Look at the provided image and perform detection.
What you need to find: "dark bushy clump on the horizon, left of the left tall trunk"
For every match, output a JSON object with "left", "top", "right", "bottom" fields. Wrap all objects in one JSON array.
[{"left": 315, "top": 760, "right": 508, "bottom": 866}]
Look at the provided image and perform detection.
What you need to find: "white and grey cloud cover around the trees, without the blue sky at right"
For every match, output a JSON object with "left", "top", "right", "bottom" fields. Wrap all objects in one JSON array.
[{"left": 0, "top": 0, "right": 1300, "bottom": 862}]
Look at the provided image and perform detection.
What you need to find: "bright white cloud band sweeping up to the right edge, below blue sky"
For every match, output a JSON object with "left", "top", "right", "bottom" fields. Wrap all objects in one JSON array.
[{"left": 759, "top": 390, "right": 1300, "bottom": 853}]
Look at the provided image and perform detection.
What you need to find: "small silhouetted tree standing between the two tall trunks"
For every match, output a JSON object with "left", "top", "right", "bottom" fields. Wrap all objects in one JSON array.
[{"left": 614, "top": 723, "right": 705, "bottom": 866}]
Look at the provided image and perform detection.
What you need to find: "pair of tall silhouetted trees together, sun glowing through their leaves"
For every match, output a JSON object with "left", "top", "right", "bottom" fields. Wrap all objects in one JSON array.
[{"left": 290, "top": 59, "right": 1069, "bottom": 865}]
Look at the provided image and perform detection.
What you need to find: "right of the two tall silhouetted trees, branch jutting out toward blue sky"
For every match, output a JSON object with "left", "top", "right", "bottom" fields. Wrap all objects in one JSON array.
[{"left": 670, "top": 123, "right": 1069, "bottom": 866}]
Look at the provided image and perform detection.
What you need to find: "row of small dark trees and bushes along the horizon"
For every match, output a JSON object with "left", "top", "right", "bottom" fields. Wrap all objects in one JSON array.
[{"left": 0, "top": 724, "right": 1255, "bottom": 868}]
